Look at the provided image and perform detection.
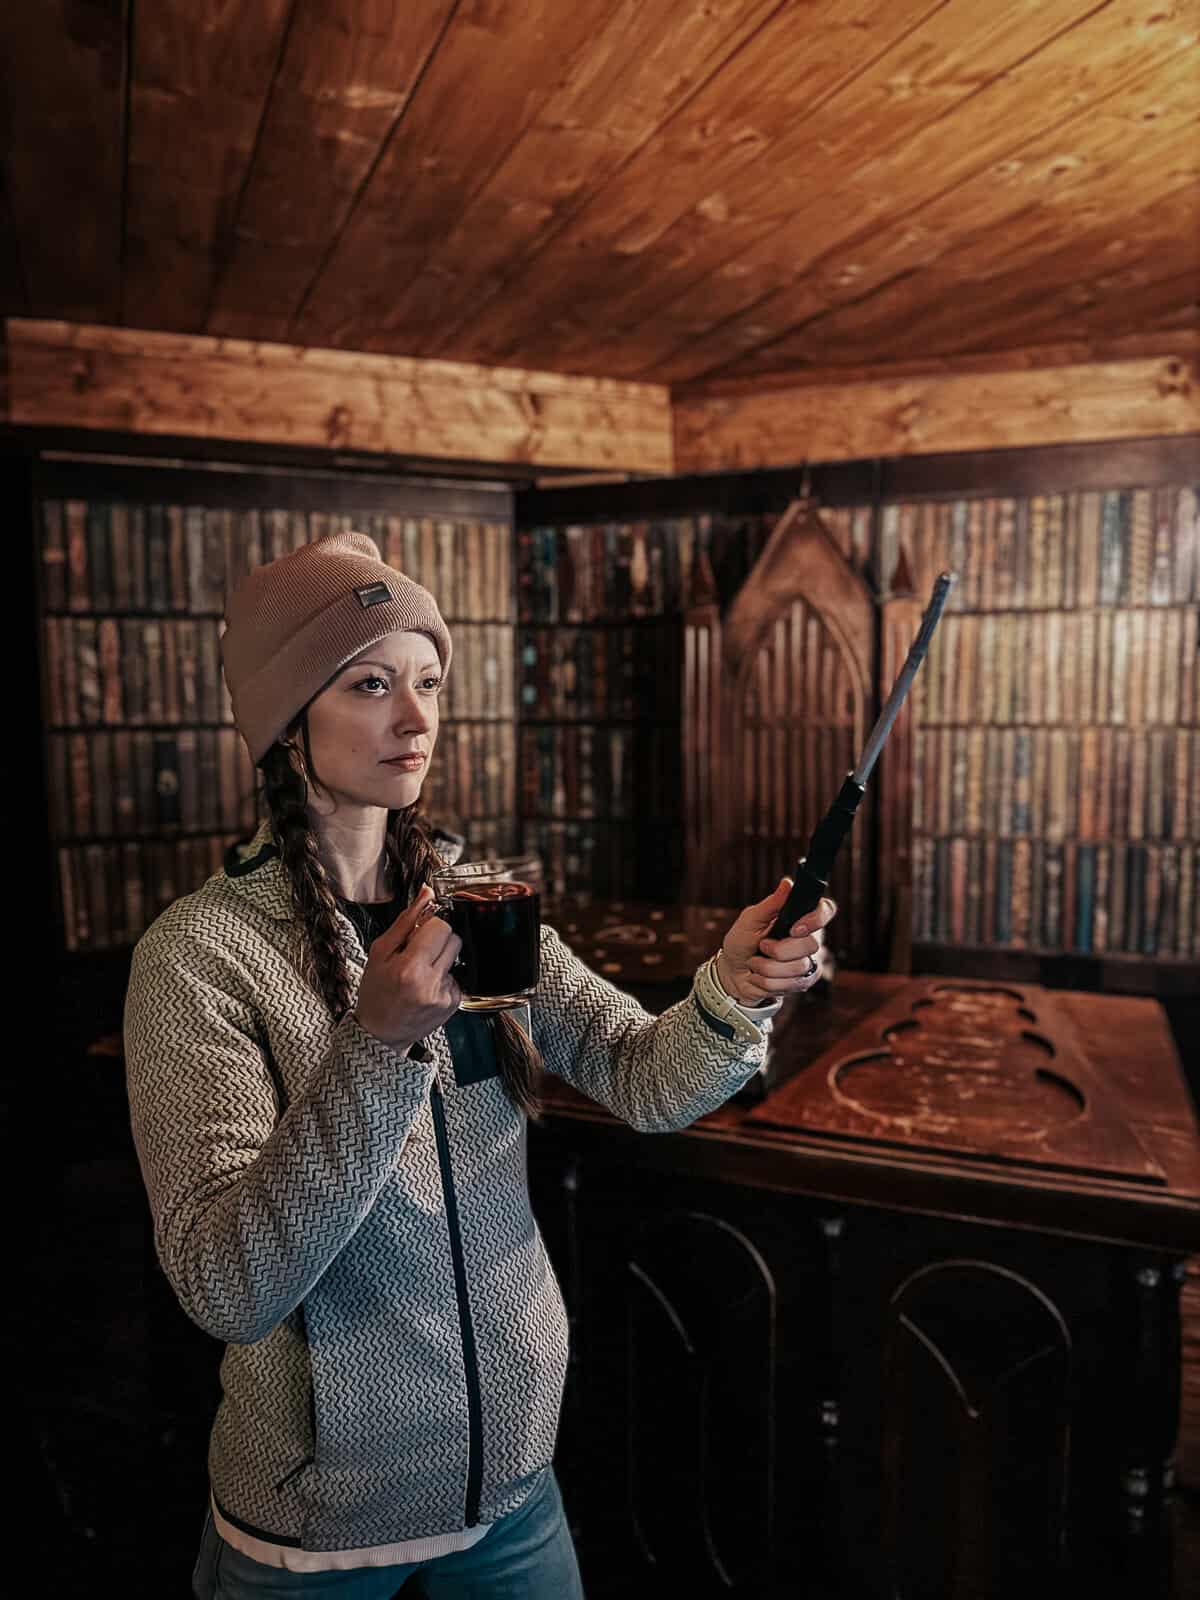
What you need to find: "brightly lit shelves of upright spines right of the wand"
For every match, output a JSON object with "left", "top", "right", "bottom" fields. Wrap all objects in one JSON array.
[{"left": 908, "top": 485, "right": 1200, "bottom": 963}]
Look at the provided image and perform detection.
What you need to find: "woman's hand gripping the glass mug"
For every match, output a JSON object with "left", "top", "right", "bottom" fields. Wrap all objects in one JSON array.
[{"left": 354, "top": 883, "right": 462, "bottom": 1050}]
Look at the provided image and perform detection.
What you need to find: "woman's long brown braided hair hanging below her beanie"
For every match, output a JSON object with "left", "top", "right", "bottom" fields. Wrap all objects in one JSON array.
[{"left": 259, "top": 710, "right": 542, "bottom": 1122}]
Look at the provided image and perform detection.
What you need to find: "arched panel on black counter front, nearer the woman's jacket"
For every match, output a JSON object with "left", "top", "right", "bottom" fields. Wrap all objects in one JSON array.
[{"left": 624, "top": 1211, "right": 776, "bottom": 1600}]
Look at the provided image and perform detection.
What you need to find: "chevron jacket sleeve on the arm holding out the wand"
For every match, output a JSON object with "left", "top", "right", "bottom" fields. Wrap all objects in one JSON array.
[{"left": 531, "top": 926, "right": 770, "bottom": 1133}]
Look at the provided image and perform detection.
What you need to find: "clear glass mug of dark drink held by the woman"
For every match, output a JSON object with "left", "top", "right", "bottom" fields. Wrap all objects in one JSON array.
[{"left": 432, "top": 854, "right": 542, "bottom": 1011}]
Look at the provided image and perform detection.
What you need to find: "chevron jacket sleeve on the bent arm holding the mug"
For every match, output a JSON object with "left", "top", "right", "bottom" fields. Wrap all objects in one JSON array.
[{"left": 125, "top": 923, "right": 434, "bottom": 1342}]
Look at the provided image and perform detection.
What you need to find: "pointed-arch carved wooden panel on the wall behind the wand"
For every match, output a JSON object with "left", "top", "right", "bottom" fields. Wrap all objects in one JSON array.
[{"left": 683, "top": 501, "right": 875, "bottom": 965}]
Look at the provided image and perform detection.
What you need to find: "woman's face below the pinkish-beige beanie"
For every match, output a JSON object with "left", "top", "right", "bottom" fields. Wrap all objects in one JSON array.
[{"left": 309, "top": 634, "right": 442, "bottom": 814}]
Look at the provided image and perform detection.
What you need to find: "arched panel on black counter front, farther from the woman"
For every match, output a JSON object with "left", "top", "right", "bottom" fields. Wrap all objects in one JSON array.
[{"left": 883, "top": 1259, "right": 1072, "bottom": 1600}]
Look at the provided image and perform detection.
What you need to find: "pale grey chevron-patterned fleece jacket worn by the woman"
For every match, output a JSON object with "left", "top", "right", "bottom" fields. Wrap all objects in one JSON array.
[{"left": 125, "top": 827, "right": 770, "bottom": 1550}]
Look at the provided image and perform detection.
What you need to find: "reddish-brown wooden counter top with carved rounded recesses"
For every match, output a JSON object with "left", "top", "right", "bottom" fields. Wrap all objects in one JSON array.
[{"left": 534, "top": 901, "right": 1200, "bottom": 1253}]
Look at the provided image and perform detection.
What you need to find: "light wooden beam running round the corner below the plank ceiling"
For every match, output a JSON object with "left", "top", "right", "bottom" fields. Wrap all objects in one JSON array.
[{"left": 6, "top": 318, "right": 1200, "bottom": 477}]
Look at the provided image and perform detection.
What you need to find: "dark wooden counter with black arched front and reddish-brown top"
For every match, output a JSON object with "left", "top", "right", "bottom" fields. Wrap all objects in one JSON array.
[{"left": 530, "top": 902, "right": 1200, "bottom": 1600}]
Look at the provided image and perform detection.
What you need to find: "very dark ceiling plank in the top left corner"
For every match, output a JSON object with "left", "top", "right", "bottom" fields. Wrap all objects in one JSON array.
[{"left": 0, "top": 0, "right": 128, "bottom": 320}]
